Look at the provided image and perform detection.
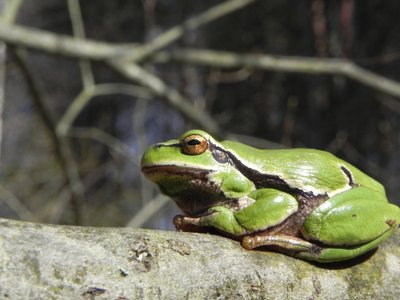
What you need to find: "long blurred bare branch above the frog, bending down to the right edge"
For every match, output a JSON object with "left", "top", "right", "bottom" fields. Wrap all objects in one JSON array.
[{"left": 155, "top": 49, "right": 400, "bottom": 97}]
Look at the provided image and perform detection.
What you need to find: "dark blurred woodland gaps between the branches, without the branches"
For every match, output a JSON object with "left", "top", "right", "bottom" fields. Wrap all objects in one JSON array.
[{"left": 0, "top": 0, "right": 400, "bottom": 228}]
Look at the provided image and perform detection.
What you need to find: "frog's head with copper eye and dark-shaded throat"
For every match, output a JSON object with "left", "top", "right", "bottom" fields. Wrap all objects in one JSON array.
[{"left": 141, "top": 130, "right": 254, "bottom": 215}]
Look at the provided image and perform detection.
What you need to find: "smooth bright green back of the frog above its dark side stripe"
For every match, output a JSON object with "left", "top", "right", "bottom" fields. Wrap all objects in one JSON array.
[{"left": 224, "top": 141, "right": 385, "bottom": 195}]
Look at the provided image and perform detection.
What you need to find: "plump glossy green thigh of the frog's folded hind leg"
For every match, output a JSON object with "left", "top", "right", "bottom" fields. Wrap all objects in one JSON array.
[{"left": 302, "top": 187, "right": 399, "bottom": 245}]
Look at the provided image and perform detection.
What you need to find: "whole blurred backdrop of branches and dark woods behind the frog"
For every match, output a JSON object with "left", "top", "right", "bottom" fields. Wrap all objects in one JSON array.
[{"left": 0, "top": 0, "right": 400, "bottom": 229}]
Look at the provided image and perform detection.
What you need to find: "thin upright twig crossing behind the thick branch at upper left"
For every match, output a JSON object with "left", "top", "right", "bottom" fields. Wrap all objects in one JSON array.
[{"left": 68, "top": 0, "right": 95, "bottom": 88}]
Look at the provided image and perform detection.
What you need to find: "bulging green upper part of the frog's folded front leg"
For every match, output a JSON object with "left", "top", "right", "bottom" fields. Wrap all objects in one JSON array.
[{"left": 234, "top": 189, "right": 298, "bottom": 232}]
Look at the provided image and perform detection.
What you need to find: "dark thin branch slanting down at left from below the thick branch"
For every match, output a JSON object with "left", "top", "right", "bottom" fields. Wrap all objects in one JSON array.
[{"left": 13, "top": 49, "right": 84, "bottom": 224}]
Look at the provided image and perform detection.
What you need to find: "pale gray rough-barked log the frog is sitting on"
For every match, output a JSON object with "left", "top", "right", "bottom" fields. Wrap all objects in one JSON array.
[{"left": 0, "top": 219, "right": 400, "bottom": 300}]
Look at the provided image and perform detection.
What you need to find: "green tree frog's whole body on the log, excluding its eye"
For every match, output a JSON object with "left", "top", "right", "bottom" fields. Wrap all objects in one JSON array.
[{"left": 142, "top": 130, "right": 400, "bottom": 262}]
